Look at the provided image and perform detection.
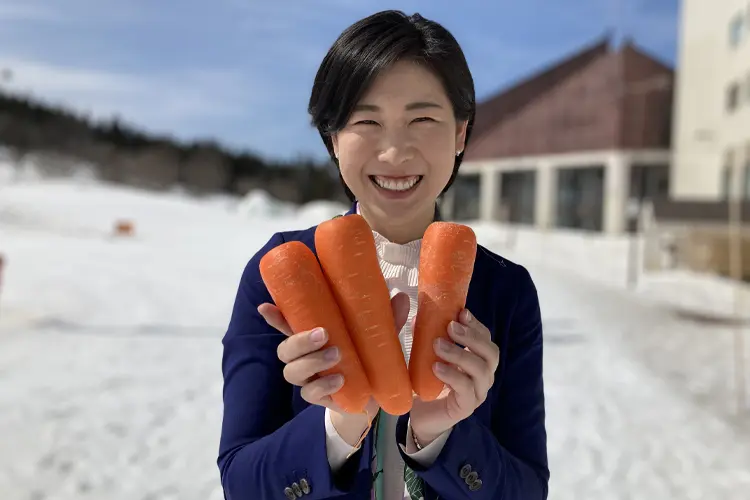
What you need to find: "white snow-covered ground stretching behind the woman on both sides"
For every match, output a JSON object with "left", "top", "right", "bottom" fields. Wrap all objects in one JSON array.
[{"left": 0, "top": 170, "right": 750, "bottom": 500}]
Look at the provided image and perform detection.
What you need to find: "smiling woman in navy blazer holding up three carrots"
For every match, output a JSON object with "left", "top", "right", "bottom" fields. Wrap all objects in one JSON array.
[{"left": 218, "top": 11, "right": 549, "bottom": 500}]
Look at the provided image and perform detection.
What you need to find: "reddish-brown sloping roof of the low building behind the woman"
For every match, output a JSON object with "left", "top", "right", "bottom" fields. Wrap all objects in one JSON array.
[{"left": 464, "top": 35, "right": 673, "bottom": 161}]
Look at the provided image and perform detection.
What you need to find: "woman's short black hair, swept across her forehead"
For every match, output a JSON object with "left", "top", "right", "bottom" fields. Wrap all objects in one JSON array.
[{"left": 308, "top": 10, "right": 476, "bottom": 201}]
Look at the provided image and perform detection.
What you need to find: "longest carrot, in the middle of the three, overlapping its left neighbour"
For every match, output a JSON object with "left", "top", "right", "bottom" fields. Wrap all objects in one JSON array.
[{"left": 315, "top": 214, "right": 413, "bottom": 415}]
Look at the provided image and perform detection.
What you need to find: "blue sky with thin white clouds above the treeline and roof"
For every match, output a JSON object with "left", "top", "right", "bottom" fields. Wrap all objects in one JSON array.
[{"left": 0, "top": 0, "right": 679, "bottom": 159}]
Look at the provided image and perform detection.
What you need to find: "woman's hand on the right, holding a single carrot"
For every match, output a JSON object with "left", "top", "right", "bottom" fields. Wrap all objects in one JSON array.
[{"left": 410, "top": 309, "right": 500, "bottom": 446}]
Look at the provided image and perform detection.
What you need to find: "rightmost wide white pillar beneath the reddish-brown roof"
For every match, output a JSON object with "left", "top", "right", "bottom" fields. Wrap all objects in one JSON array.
[{"left": 603, "top": 153, "right": 630, "bottom": 235}]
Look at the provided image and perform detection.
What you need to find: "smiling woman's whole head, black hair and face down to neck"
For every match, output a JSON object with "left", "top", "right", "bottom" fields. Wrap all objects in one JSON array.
[{"left": 309, "top": 14, "right": 475, "bottom": 246}]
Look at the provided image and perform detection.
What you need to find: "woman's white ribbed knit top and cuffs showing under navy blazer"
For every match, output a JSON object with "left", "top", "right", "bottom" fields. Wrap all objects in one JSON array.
[{"left": 325, "top": 210, "right": 450, "bottom": 500}]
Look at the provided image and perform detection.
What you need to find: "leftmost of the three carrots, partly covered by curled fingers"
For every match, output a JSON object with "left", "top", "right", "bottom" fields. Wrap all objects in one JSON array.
[{"left": 260, "top": 241, "right": 372, "bottom": 413}]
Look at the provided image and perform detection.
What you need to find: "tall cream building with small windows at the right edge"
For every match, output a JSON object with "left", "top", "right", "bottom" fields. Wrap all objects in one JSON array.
[{"left": 670, "top": 0, "right": 750, "bottom": 201}]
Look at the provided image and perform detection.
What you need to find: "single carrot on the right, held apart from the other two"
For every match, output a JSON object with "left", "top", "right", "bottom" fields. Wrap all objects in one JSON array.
[{"left": 409, "top": 222, "right": 477, "bottom": 401}]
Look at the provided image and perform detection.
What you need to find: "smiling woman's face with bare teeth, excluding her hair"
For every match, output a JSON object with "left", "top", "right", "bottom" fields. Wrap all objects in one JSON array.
[{"left": 332, "top": 61, "right": 466, "bottom": 230}]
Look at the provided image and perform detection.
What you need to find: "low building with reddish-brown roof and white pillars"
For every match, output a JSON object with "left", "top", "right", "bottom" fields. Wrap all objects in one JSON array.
[{"left": 444, "top": 38, "right": 674, "bottom": 234}]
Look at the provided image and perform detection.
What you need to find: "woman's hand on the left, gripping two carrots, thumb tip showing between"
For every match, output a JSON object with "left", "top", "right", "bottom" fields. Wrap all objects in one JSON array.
[{"left": 258, "top": 293, "right": 409, "bottom": 446}]
